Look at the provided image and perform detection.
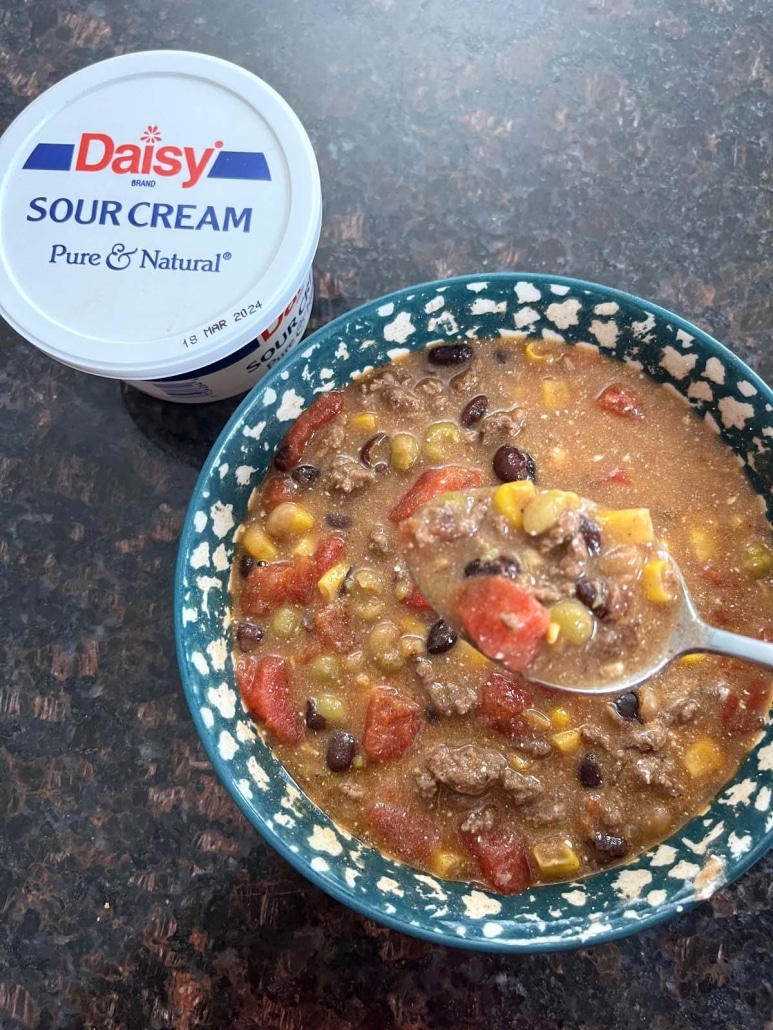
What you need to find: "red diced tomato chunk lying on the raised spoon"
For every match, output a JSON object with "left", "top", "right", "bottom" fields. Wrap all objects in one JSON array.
[{"left": 457, "top": 576, "right": 550, "bottom": 673}]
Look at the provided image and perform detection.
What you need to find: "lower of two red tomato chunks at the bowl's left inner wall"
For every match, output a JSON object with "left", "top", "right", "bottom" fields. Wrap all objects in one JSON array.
[{"left": 236, "top": 654, "right": 303, "bottom": 744}]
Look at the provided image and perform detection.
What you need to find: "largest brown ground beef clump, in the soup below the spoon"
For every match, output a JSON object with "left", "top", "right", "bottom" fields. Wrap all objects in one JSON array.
[{"left": 414, "top": 744, "right": 544, "bottom": 804}]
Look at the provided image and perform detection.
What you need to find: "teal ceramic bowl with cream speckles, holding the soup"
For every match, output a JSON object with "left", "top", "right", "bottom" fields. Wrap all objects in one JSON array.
[{"left": 175, "top": 274, "right": 773, "bottom": 952}]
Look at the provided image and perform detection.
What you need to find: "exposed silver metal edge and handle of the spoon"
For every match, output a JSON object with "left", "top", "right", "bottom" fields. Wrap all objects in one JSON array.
[{"left": 405, "top": 490, "right": 773, "bottom": 694}]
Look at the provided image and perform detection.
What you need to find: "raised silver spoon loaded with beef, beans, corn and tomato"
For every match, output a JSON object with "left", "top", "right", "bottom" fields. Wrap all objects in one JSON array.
[{"left": 402, "top": 483, "right": 773, "bottom": 694}]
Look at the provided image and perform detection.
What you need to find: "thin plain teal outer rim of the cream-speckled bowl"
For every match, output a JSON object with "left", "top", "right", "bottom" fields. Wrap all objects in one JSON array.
[{"left": 173, "top": 271, "right": 773, "bottom": 955}]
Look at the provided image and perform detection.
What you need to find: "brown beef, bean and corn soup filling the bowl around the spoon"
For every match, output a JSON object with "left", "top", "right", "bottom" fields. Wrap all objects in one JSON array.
[{"left": 226, "top": 338, "right": 773, "bottom": 893}]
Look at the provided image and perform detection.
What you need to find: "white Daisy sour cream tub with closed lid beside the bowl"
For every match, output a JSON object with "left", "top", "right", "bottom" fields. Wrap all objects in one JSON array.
[{"left": 0, "top": 50, "right": 322, "bottom": 404}]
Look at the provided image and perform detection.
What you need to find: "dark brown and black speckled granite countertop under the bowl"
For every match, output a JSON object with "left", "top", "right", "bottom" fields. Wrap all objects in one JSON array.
[{"left": 0, "top": 0, "right": 773, "bottom": 1030}]
